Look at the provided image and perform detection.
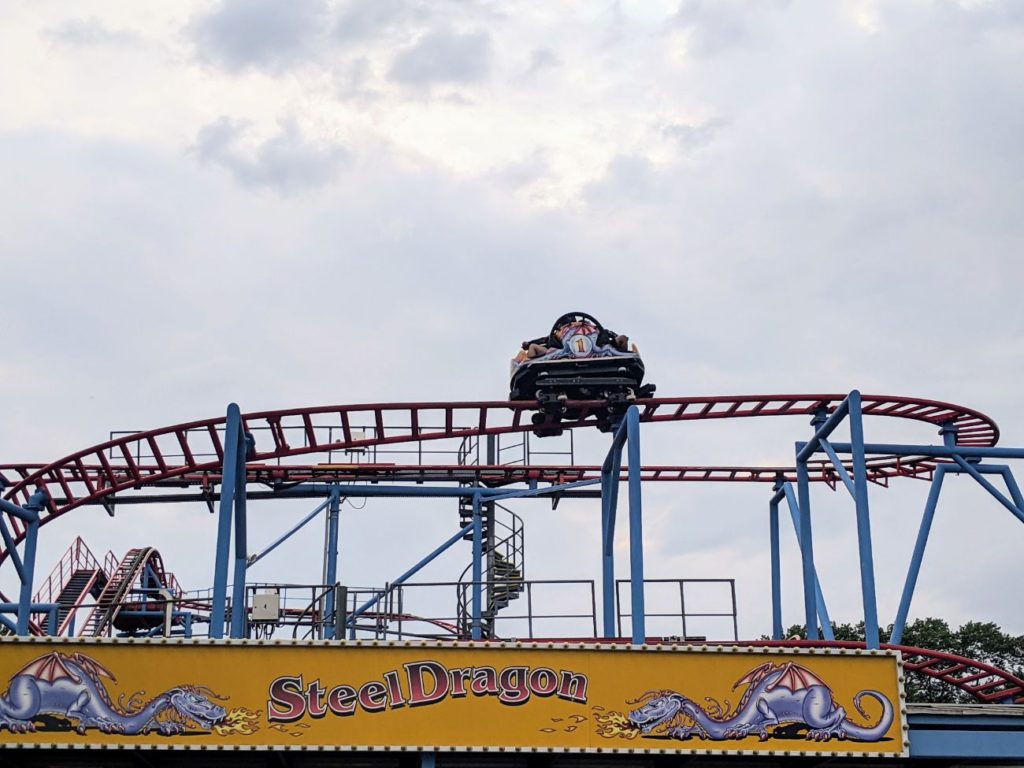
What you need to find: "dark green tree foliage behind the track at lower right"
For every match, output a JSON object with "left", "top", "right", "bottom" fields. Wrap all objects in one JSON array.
[{"left": 785, "top": 617, "right": 1024, "bottom": 703}]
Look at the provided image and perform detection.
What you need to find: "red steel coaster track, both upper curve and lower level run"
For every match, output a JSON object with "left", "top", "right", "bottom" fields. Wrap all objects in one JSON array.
[{"left": 0, "top": 394, "right": 999, "bottom": 562}]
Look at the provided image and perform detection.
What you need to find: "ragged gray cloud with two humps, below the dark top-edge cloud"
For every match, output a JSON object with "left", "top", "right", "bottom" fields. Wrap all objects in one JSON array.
[{"left": 193, "top": 118, "right": 348, "bottom": 196}]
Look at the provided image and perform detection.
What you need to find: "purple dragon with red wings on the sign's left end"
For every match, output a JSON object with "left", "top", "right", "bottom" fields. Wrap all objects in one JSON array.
[{"left": 0, "top": 651, "right": 227, "bottom": 736}]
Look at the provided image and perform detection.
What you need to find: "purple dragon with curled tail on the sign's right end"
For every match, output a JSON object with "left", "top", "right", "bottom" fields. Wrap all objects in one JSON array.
[{"left": 629, "top": 662, "right": 893, "bottom": 741}]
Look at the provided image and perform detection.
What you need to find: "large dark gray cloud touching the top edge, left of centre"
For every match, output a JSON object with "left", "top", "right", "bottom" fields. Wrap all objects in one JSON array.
[{"left": 189, "top": 0, "right": 328, "bottom": 72}]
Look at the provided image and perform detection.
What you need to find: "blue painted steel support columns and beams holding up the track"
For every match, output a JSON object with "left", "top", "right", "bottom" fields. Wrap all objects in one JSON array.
[{"left": 0, "top": 390, "right": 1024, "bottom": 765}]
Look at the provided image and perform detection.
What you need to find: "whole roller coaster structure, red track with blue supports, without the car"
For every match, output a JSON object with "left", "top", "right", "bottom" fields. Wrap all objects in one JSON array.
[{"left": 0, "top": 378, "right": 1024, "bottom": 757}]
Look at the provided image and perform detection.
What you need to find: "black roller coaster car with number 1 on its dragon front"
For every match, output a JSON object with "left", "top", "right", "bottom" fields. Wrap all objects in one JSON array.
[{"left": 509, "top": 312, "right": 654, "bottom": 437}]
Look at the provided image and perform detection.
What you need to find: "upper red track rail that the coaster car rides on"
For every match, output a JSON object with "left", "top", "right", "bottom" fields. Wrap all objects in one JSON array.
[{"left": 0, "top": 394, "right": 999, "bottom": 562}]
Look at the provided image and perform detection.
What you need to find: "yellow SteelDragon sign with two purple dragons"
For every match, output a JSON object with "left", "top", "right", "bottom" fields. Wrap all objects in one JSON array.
[{"left": 0, "top": 638, "right": 907, "bottom": 755}]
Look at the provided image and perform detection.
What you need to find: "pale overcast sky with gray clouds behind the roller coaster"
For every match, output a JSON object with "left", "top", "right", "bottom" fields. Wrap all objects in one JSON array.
[{"left": 0, "top": 0, "right": 1024, "bottom": 636}]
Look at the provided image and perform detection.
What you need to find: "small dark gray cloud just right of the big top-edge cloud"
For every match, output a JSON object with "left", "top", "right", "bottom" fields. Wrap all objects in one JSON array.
[{"left": 390, "top": 30, "right": 494, "bottom": 86}]
